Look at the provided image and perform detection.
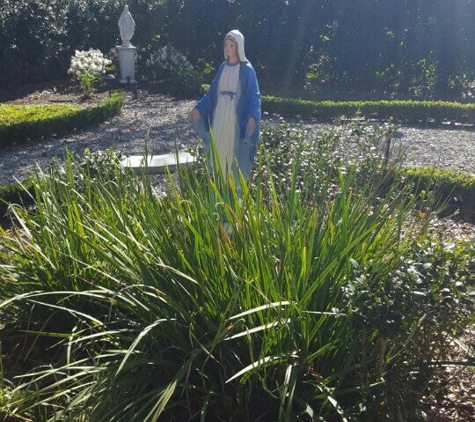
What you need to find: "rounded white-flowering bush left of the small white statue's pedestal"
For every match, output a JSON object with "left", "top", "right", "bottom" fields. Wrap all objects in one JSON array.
[{"left": 68, "top": 48, "right": 112, "bottom": 97}]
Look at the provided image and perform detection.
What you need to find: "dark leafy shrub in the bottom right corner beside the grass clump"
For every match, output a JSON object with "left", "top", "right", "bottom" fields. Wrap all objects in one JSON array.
[{"left": 345, "top": 231, "right": 475, "bottom": 421}]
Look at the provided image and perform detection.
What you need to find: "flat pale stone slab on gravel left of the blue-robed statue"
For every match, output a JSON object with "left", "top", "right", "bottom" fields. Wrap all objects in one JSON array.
[{"left": 121, "top": 152, "right": 196, "bottom": 174}]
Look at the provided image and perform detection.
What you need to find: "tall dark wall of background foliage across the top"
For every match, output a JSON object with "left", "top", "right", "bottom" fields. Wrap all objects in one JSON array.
[{"left": 0, "top": 0, "right": 475, "bottom": 100}]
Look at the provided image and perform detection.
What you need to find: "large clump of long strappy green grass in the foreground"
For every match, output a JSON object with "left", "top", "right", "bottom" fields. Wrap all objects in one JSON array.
[{"left": 0, "top": 127, "right": 470, "bottom": 422}]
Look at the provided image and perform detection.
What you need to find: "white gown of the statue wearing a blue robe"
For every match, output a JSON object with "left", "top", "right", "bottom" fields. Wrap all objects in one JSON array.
[{"left": 211, "top": 63, "right": 240, "bottom": 174}]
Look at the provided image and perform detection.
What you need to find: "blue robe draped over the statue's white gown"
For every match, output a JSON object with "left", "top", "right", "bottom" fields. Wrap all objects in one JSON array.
[{"left": 194, "top": 61, "right": 261, "bottom": 180}]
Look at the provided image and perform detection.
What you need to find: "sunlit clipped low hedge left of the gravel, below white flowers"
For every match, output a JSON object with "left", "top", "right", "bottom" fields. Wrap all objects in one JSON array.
[{"left": 0, "top": 92, "right": 123, "bottom": 147}]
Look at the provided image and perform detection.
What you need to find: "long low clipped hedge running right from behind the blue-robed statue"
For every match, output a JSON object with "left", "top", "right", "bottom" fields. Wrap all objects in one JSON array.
[{"left": 262, "top": 95, "right": 475, "bottom": 123}]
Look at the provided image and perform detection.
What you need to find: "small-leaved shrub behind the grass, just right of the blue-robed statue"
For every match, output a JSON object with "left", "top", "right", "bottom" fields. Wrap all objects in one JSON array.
[{"left": 261, "top": 118, "right": 404, "bottom": 201}]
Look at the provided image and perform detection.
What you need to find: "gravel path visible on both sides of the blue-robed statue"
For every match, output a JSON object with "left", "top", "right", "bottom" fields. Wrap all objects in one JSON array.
[{"left": 0, "top": 92, "right": 475, "bottom": 185}]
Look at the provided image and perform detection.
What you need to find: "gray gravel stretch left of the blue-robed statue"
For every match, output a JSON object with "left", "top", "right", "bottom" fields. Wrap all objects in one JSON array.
[{"left": 0, "top": 93, "right": 197, "bottom": 185}]
